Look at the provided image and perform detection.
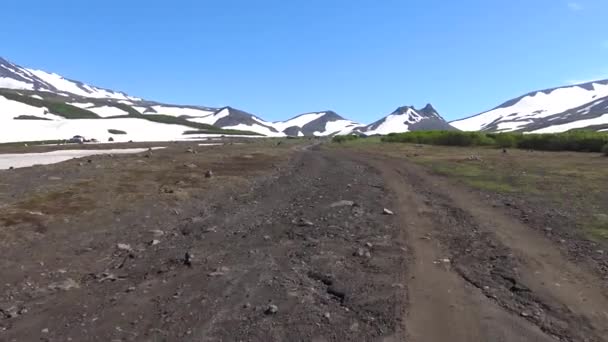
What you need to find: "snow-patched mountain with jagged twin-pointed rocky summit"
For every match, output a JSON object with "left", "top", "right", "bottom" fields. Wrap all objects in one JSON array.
[{"left": 356, "top": 104, "right": 455, "bottom": 135}]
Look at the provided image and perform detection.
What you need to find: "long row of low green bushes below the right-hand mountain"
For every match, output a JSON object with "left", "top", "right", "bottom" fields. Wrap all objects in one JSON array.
[{"left": 382, "top": 130, "right": 608, "bottom": 152}]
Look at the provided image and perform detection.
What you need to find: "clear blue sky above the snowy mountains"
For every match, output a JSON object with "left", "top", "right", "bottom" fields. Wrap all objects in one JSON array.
[{"left": 0, "top": 0, "right": 608, "bottom": 123}]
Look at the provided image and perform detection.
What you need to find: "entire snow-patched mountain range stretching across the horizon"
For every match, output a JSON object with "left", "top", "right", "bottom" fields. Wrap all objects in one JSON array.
[{"left": 0, "top": 58, "right": 608, "bottom": 142}]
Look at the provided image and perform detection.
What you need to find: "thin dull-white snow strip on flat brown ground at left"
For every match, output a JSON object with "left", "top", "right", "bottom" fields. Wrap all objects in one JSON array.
[{"left": 0, "top": 147, "right": 165, "bottom": 170}]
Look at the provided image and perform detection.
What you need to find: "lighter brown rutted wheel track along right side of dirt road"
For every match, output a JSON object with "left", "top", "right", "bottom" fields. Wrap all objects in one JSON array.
[{"left": 358, "top": 152, "right": 608, "bottom": 341}]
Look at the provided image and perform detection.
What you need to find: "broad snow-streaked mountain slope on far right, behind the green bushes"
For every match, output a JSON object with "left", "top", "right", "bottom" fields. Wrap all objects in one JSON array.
[{"left": 450, "top": 80, "right": 608, "bottom": 133}]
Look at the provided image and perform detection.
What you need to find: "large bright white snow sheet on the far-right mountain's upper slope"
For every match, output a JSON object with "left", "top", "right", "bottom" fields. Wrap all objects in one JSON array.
[{"left": 450, "top": 83, "right": 608, "bottom": 131}]
